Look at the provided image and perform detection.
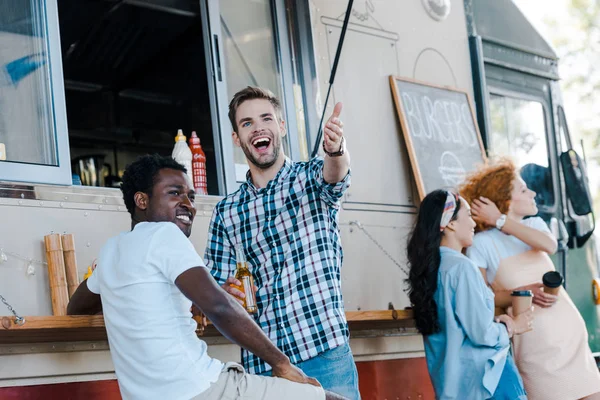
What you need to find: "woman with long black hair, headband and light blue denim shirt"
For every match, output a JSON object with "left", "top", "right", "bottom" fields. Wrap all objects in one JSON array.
[{"left": 407, "top": 190, "right": 532, "bottom": 400}]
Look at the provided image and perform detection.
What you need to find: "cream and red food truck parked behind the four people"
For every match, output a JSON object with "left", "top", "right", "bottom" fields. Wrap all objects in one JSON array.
[{"left": 0, "top": 0, "right": 600, "bottom": 400}]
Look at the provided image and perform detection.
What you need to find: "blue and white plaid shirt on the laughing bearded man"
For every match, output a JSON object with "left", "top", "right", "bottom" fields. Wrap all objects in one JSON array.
[{"left": 205, "top": 158, "right": 350, "bottom": 374}]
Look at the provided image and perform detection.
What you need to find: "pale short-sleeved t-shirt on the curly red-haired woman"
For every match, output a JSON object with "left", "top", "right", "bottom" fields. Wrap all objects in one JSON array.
[{"left": 467, "top": 217, "right": 550, "bottom": 283}]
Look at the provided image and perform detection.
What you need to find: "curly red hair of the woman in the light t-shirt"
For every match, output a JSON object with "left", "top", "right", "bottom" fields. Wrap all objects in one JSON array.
[{"left": 458, "top": 158, "right": 517, "bottom": 232}]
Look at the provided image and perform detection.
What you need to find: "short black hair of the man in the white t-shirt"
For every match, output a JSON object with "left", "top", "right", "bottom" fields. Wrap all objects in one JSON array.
[{"left": 121, "top": 154, "right": 187, "bottom": 217}]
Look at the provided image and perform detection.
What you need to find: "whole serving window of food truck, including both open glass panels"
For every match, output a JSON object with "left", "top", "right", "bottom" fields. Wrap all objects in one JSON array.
[{"left": 0, "top": 0, "right": 314, "bottom": 195}]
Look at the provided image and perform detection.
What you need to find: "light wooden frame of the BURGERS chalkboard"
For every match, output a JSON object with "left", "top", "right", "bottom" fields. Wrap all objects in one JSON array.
[{"left": 389, "top": 75, "right": 487, "bottom": 200}]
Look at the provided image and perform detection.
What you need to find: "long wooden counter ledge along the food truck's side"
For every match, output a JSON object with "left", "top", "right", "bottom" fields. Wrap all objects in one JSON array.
[{"left": 0, "top": 310, "right": 413, "bottom": 344}]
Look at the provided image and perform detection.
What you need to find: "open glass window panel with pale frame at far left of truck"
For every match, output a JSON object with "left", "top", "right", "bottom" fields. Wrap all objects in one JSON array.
[{"left": 0, "top": 0, "right": 71, "bottom": 184}]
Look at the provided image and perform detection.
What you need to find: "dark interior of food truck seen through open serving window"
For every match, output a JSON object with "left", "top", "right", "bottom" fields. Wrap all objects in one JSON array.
[{"left": 58, "top": 0, "right": 219, "bottom": 194}]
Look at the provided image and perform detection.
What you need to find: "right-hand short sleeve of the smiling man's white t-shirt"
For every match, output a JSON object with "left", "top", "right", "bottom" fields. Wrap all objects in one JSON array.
[{"left": 148, "top": 222, "right": 206, "bottom": 283}]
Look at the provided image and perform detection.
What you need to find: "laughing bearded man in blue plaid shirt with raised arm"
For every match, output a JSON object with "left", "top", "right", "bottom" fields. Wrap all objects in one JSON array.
[{"left": 205, "top": 87, "right": 360, "bottom": 399}]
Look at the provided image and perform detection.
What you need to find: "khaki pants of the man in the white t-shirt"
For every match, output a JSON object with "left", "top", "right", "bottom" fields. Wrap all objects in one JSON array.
[{"left": 192, "top": 362, "right": 325, "bottom": 400}]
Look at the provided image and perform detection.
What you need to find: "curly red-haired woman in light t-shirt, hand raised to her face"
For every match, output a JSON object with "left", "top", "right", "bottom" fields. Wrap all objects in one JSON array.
[{"left": 460, "top": 159, "right": 600, "bottom": 400}]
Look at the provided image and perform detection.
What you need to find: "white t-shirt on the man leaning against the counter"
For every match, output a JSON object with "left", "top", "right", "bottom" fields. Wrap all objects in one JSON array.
[{"left": 87, "top": 222, "right": 223, "bottom": 400}]
